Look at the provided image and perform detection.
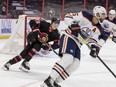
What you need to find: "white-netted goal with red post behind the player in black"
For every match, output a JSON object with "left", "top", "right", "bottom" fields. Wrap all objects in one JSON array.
[{"left": 0, "top": 15, "right": 40, "bottom": 54}]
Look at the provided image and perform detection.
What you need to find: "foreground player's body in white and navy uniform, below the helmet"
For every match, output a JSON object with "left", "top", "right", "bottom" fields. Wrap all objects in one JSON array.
[{"left": 41, "top": 11, "right": 106, "bottom": 87}]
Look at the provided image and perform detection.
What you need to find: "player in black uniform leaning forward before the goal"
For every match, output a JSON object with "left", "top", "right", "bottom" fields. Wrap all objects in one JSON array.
[{"left": 3, "top": 18, "right": 60, "bottom": 71}]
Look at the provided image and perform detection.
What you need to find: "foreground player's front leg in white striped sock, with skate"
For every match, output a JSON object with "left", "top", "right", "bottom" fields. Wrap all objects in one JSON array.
[{"left": 41, "top": 54, "right": 74, "bottom": 87}]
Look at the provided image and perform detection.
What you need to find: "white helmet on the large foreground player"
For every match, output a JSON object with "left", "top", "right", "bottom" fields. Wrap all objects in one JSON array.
[{"left": 93, "top": 6, "right": 107, "bottom": 19}]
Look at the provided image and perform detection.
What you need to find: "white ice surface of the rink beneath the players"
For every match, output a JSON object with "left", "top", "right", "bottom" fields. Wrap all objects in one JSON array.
[{"left": 0, "top": 40, "right": 116, "bottom": 87}]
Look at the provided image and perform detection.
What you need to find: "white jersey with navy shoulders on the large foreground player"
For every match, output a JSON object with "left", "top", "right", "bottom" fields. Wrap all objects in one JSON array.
[{"left": 65, "top": 11, "right": 104, "bottom": 46}]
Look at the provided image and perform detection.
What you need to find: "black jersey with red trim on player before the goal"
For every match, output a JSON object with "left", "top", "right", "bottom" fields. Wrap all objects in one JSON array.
[{"left": 28, "top": 20, "right": 60, "bottom": 49}]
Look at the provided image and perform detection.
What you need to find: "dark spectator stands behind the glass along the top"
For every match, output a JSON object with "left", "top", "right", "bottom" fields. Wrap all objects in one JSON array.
[{"left": 0, "top": 0, "right": 116, "bottom": 19}]
